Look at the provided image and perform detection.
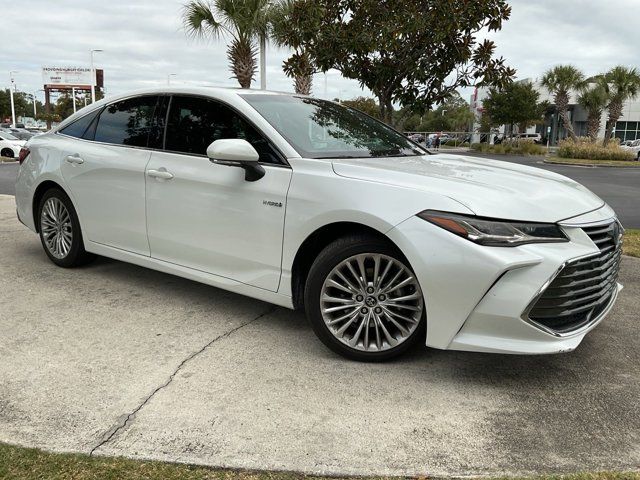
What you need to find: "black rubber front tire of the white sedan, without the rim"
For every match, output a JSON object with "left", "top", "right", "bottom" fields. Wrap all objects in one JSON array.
[{"left": 304, "top": 235, "right": 426, "bottom": 362}]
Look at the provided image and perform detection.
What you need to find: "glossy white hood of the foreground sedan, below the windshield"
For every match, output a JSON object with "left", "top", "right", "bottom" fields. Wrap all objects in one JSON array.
[{"left": 332, "top": 154, "right": 604, "bottom": 222}]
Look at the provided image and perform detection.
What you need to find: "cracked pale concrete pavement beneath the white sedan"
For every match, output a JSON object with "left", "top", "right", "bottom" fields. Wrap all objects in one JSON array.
[{"left": 0, "top": 196, "right": 640, "bottom": 476}]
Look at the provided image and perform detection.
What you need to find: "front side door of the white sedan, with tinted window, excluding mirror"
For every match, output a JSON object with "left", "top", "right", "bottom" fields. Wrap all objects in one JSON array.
[{"left": 146, "top": 96, "right": 291, "bottom": 291}]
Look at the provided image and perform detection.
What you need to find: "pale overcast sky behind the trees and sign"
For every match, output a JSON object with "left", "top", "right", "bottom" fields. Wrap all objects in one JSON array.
[{"left": 0, "top": 0, "right": 640, "bottom": 105}]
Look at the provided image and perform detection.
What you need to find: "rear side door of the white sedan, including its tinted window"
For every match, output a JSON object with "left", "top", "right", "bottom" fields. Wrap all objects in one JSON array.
[{"left": 60, "top": 95, "right": 160, "bottom": 256}]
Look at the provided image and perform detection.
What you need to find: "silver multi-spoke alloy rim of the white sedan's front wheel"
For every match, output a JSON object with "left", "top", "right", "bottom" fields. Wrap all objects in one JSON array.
[{"left": 320, "top": 253, "right": 424, "bottom": 352}]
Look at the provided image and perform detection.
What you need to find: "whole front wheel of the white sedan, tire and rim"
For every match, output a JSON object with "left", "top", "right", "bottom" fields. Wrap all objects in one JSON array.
[{"left": 305, "top": 236, "right": 425, "bottom": 361}]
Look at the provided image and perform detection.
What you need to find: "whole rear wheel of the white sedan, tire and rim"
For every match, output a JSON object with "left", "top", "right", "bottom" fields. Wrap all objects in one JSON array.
[{"left": 38, "top": 188, "right": 95, "bottom": 268}]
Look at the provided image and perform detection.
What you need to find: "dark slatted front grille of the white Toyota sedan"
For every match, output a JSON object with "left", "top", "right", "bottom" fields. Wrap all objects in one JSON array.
[{"left": 529, "top": 220, "right": 622, "bottom": 334}]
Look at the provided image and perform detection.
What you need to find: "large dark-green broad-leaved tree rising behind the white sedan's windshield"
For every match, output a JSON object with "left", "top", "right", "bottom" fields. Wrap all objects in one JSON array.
[{"left": 284, "top": 0, "right": 515, "bottom": 123}]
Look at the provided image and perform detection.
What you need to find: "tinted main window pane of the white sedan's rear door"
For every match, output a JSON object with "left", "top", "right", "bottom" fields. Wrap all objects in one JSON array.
[{"left": 95, "top": 95, "right": 158, "bottom": 147}]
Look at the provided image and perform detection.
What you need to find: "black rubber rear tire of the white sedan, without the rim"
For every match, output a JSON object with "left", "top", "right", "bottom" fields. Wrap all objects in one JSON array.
[{"left": 36, "top": 188, "right": 95, "bottom": 268}]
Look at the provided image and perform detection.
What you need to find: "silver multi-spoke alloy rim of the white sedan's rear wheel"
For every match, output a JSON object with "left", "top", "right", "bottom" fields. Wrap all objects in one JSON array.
[{"left": 40, "top": 197, "right": 73, "bottom": 259}]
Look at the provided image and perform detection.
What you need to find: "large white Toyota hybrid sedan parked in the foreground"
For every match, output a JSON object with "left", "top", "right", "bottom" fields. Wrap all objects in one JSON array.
[{"left": 16, "top": 87, "right": 623, "bottom": 361}]
